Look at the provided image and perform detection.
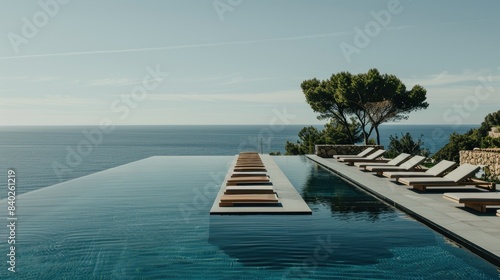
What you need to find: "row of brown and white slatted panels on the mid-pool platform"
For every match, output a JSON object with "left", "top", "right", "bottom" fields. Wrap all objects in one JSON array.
[{"left": 219, "top": 152, "right": 280, "bottom": 207}]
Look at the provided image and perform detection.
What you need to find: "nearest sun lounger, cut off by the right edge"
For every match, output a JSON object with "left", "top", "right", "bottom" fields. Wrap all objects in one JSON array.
[{"left": 443, "top": 192, "right": 500, "bottom": 214}]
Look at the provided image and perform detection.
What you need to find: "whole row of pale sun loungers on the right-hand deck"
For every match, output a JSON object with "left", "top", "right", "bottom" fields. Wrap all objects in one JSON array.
[{"left": 334, "top": 148, "right": 500, "bottom": 213}]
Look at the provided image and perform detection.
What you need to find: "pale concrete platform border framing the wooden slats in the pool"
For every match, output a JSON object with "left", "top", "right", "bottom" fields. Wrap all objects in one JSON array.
[{"left": 210, "top": 155, "right": 312, "bottom": 215}]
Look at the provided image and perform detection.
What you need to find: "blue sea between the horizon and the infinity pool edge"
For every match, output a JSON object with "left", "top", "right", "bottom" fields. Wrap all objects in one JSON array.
[{"left": 0, "top": 124, "right": 479, "bottom": 199}]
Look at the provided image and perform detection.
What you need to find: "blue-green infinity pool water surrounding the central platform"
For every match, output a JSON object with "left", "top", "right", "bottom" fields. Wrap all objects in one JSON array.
[{"left": 0, "top": 156, "right": 499, "bottom": 279}]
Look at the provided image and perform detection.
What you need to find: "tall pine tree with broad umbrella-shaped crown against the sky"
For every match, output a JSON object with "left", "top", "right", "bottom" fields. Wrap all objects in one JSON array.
[{"left": 301, "top": 69, "right": 429, "bottom": 144}]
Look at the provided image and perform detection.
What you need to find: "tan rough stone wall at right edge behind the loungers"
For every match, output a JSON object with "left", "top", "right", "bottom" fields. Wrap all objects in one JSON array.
[{"left": 460, "top": 148, "right": 500, "bottom": 181}]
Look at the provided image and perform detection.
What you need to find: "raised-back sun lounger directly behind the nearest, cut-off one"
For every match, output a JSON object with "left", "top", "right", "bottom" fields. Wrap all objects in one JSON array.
[{"left": 398, "top": 163, "right": 495, "bottom": 191}]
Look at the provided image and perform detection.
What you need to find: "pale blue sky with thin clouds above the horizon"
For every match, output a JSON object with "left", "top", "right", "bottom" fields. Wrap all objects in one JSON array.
[{"left": 0, "top": 0, "right": 500, "bottom": 125}]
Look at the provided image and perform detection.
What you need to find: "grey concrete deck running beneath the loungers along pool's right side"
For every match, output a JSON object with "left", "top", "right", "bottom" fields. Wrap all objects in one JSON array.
[{"left": 307, "top": 155, "right": 500, "bottom": 266}]
